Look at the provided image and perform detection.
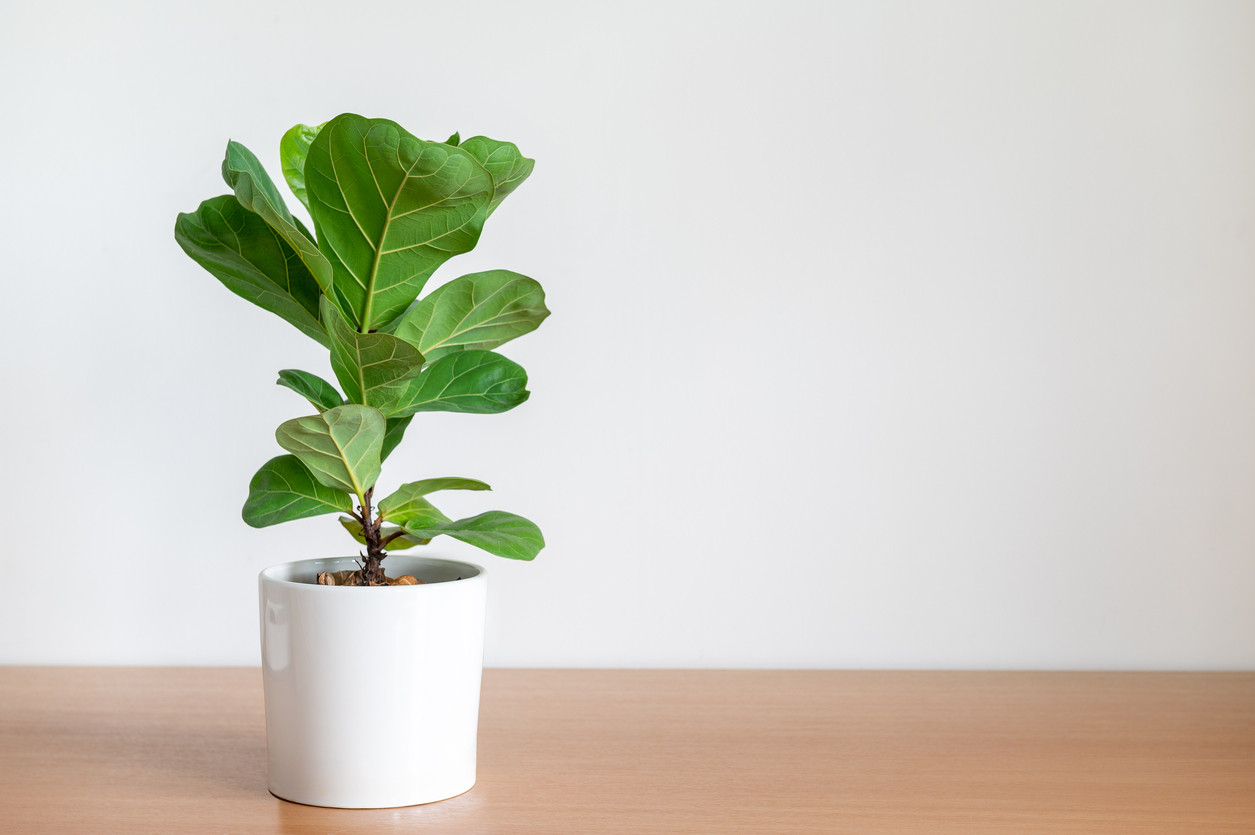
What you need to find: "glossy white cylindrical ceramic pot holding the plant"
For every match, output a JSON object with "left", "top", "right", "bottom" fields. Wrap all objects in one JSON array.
[{"left": 259, "top": 555, "right": 488, "bottom": 809}]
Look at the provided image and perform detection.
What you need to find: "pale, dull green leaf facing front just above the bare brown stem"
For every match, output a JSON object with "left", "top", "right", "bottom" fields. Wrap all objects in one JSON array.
[{"left": 275, "top": 406, "right": 384, "bottom": 498}]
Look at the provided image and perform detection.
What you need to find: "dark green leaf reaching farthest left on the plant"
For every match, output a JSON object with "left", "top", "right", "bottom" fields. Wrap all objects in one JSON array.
[{"left": 174, "top": 195, "right": 331, "bottom": 347}]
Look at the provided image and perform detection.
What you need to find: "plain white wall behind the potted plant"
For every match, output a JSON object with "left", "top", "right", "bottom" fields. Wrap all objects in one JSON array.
[{"left": 0, "top": 0, "right": 1255, "bottom": 669}]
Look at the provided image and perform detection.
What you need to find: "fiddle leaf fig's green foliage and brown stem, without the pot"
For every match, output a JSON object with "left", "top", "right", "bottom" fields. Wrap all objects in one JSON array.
[{"left": 174, "top": 113, "right": 550, "bottom": 585}]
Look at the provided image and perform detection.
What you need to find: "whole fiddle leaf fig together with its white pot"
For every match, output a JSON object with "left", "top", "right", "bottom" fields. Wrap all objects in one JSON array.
[{"left": 174, "top": 113, "right": 548, "bottom": 807}]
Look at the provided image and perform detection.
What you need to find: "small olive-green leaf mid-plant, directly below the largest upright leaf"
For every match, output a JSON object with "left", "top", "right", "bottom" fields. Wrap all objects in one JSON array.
[{"left": 323, "top": 296, "right": 423, "bottom": 416}]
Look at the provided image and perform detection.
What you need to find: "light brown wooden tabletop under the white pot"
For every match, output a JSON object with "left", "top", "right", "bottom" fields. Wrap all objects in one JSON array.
[{"left": 0, "top": 667, "right": 1255, "bottom": 835}]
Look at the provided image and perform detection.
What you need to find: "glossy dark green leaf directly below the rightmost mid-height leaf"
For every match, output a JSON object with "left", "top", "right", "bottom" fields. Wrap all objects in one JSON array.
[{"left": 392, "top": 350, "right": 531, "bottom": 416}]
